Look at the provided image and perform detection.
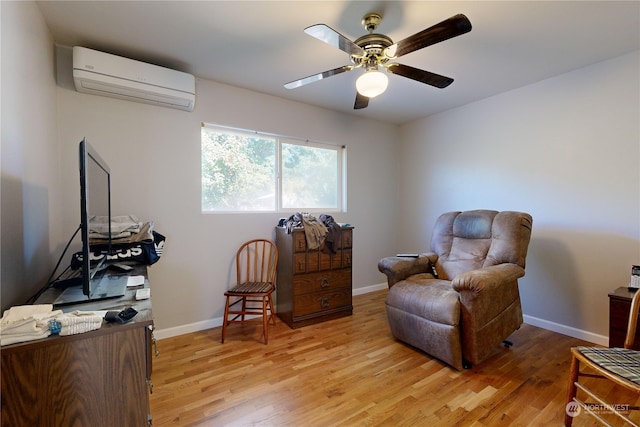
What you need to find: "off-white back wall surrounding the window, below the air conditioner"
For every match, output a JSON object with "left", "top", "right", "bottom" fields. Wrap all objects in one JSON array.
[{"left": 53, "top": 47, "right": 398, "bottom": 336}]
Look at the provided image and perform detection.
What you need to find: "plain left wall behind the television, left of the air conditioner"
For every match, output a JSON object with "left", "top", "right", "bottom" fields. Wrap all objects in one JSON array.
[{"left": 0, "top": 1, "right": 65, "bottom": 310}]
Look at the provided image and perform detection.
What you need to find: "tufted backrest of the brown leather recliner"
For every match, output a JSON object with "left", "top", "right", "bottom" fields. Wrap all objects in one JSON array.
[{"left": 431, "top": 210, "right": 533, "bottom": 280}]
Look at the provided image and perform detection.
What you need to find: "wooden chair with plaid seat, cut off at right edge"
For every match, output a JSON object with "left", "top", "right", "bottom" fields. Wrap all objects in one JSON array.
[{"left": 564, "top": 291, "right": 640, "bottom": 426}]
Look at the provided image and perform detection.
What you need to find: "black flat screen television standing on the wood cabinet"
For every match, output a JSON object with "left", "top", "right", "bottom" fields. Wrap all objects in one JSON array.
[{"left": 54, "top": 139, "right": 127, "bottom": 306}]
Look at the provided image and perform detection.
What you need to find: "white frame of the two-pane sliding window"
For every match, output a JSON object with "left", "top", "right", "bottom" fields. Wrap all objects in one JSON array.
[{"left": 200, "top": 123, "right": 347, "bottom": 214}]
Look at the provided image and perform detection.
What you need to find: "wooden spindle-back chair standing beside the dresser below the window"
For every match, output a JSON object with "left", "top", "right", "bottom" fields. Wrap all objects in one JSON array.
[{"left": 220, "top": 239, "right": 278, "bottom": 344}]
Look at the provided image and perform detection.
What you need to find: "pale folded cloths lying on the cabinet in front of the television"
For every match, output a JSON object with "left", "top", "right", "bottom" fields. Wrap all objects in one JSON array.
[{"left": 0, "top": 304, "right": 103, "bottom": 346}]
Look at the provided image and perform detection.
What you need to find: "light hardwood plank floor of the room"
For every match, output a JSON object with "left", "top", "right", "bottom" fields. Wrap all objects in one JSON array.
[{"left": 151, "top": 290, "right": 640, "bottom": 427}]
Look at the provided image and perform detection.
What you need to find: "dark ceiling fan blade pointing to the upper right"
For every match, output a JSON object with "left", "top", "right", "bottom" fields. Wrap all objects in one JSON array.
[{"left": 384, "top": 14, "right": 471, "bottom": 58}]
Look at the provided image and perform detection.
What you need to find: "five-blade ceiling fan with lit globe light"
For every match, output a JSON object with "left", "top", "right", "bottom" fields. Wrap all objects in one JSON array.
[{"left": 284, "top": 13, "right": 471, "bottom": 110}]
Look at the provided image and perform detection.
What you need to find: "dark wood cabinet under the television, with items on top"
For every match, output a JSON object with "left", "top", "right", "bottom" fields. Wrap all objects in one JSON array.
[{"left": 0, "top": 268, "right": 153, "bottom": 427}]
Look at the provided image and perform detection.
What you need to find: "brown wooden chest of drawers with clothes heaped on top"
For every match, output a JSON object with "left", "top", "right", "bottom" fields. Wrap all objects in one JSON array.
[{"left": 276, "top": 227, "right": 353, "bottom": 328}]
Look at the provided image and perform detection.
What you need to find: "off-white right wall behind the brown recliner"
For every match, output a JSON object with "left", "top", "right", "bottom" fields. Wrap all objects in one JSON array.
[{"left": 399, "top": 52, "right": 640, "bottom": 344}]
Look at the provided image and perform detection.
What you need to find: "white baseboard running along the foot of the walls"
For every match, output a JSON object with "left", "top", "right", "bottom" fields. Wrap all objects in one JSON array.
[{"left": 154, "top": 282, "right": 609, "bottom": 346}]
